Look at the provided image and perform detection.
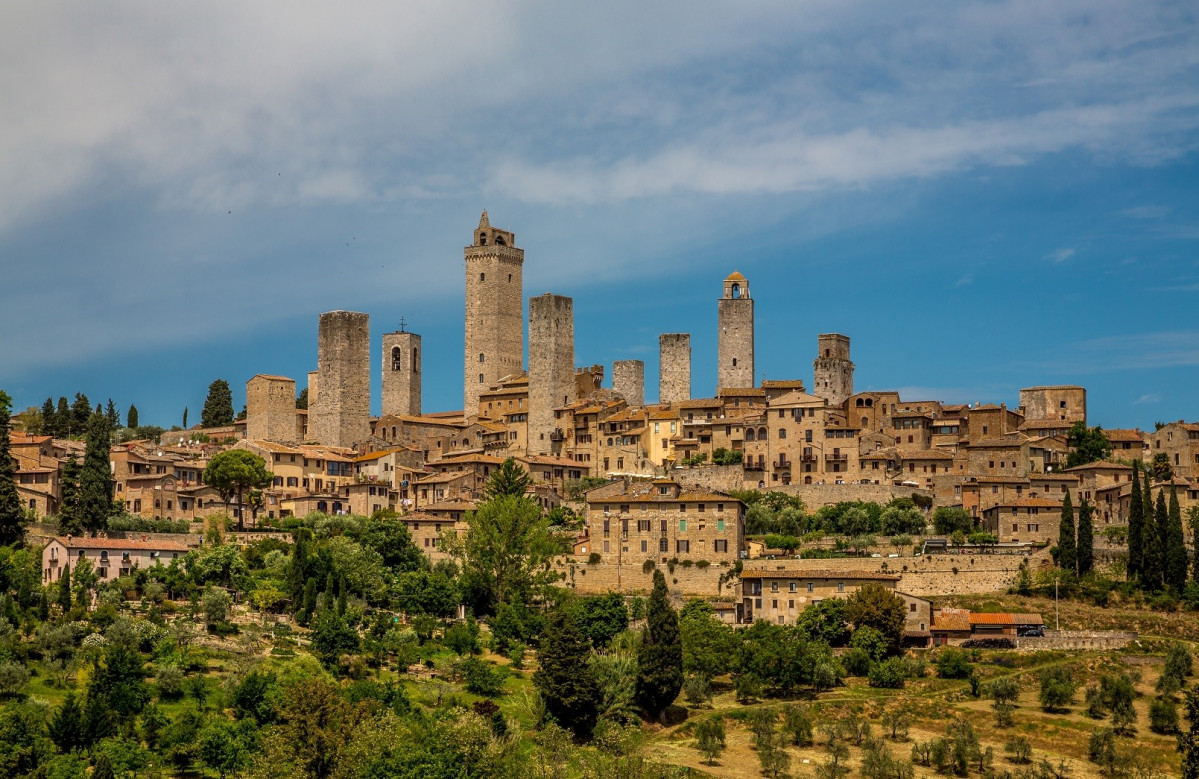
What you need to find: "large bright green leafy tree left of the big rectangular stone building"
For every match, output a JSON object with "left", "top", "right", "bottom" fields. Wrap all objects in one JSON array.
[{"left": 445, "top": 495, "right": 562, "bottom": 614}]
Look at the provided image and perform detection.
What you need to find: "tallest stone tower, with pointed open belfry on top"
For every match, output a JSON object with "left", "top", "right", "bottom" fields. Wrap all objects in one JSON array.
[{"left": 463, "top": 211, "right": 522, "bottom": 419}]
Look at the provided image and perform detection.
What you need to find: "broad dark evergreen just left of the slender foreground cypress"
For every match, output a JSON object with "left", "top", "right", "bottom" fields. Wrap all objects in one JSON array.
[{"left": 532, "top": 609, "right": 600, "bottom": 738}]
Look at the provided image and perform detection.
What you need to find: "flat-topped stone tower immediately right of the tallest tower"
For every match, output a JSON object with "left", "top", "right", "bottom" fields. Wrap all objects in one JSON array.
[{"left": 529, "top": 292, "right": 574, "bottom": 454}]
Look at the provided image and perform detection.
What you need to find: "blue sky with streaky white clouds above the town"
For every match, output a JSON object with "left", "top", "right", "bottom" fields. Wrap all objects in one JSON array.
[{"left": 0, "top": 1, "right": 1199, "bottom": 429}]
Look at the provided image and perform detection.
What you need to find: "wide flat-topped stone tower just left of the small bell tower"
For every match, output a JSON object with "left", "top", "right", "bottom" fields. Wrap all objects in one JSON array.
[{"left": 308, "top": 312, "right": 370, "bottom": 447}]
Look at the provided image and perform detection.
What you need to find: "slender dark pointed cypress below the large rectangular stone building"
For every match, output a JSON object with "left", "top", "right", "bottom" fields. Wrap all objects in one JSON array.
[{"left": 637, "top": 570, "right": 682, "bottom": 717}]
